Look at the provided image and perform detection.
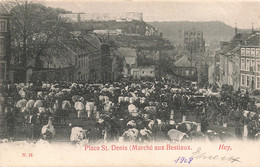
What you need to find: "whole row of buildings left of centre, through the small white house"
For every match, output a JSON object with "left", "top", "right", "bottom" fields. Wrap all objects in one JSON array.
[{"left": 0, "top": 4, "right": 155, "bottom": 83}]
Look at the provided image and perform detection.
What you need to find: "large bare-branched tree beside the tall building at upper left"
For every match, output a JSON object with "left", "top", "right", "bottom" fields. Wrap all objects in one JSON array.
[{"left": 7, "top": 0, "right": 71, "bottom": 68}]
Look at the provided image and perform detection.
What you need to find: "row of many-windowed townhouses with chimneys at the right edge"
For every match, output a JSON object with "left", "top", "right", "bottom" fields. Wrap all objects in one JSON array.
[{"left": 209, "top": 28, "right": 260, "bottom": 91}]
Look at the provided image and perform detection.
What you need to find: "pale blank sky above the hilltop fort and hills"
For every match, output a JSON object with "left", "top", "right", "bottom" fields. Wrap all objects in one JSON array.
[{"left": 44, "top": 0, "right": 260, "bottom": 29}]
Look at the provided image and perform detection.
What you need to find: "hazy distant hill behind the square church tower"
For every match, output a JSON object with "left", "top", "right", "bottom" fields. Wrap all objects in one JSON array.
[{"left": 149, "top": 21, "right": 235, "bottom": 50}]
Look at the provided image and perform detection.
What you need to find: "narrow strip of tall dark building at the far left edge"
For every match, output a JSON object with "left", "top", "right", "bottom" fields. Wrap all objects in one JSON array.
[{"left": 0, "top": 3, "right": 10, "bottom": 82}]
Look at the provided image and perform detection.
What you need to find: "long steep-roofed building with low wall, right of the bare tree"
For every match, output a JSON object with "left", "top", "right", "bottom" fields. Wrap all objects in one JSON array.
[{"left": 29, "top": 35, "right": 103, "bottom": 82}]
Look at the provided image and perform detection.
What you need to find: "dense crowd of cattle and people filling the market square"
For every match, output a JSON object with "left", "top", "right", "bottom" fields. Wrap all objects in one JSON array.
[{"left": 0, "top": 80, "right": 260, "bottom": 143}]
